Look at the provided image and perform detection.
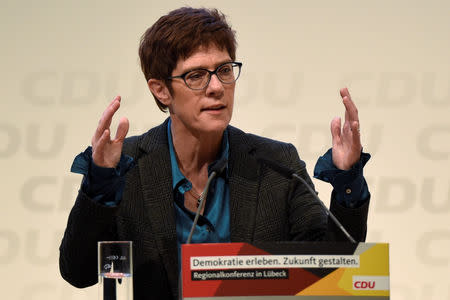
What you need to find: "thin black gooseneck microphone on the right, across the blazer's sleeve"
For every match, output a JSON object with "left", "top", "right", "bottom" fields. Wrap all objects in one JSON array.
[{"left": 256, "top": 157, "right": 356, "bottom": 243}]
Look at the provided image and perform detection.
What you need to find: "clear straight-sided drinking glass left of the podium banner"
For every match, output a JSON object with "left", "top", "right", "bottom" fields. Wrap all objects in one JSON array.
[{"left": 98, "top": 241, "right": 133, "bottom": 300}]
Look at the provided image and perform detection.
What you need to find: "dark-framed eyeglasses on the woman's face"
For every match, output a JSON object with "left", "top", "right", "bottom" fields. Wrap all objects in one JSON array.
[{"left": 167, "top": 62, "right": 242, "bottom": 90}]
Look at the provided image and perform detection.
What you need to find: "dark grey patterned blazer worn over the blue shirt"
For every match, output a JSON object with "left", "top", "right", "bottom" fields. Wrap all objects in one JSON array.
[{"left": 59, "top": 120, "right": 369, "bottom": 300}]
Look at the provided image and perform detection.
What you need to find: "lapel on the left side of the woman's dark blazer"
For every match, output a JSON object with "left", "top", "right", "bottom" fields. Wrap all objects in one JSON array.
[{"left": 138, "top": 120, "right": 178, "bottom": 295}]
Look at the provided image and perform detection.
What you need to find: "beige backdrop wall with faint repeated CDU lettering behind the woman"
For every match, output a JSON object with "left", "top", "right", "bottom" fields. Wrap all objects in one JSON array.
[{"left": 0, "top": 0, "right": 450, "bottom": 300}]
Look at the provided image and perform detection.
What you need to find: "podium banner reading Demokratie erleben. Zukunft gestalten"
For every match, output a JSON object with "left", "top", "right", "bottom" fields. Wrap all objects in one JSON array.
[{"left": 181, "top": 242, "right": 390, "bottom": 300}]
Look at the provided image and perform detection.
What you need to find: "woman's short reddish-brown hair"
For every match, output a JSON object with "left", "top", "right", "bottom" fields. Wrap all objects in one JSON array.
[{"left": 139, "top": 7, "right": 237, "bottom": 112}]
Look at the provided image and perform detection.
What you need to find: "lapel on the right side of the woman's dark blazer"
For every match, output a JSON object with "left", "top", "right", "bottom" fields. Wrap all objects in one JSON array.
[{"left": 228, "top": 126, "right": 260, "bottom": 242}]
